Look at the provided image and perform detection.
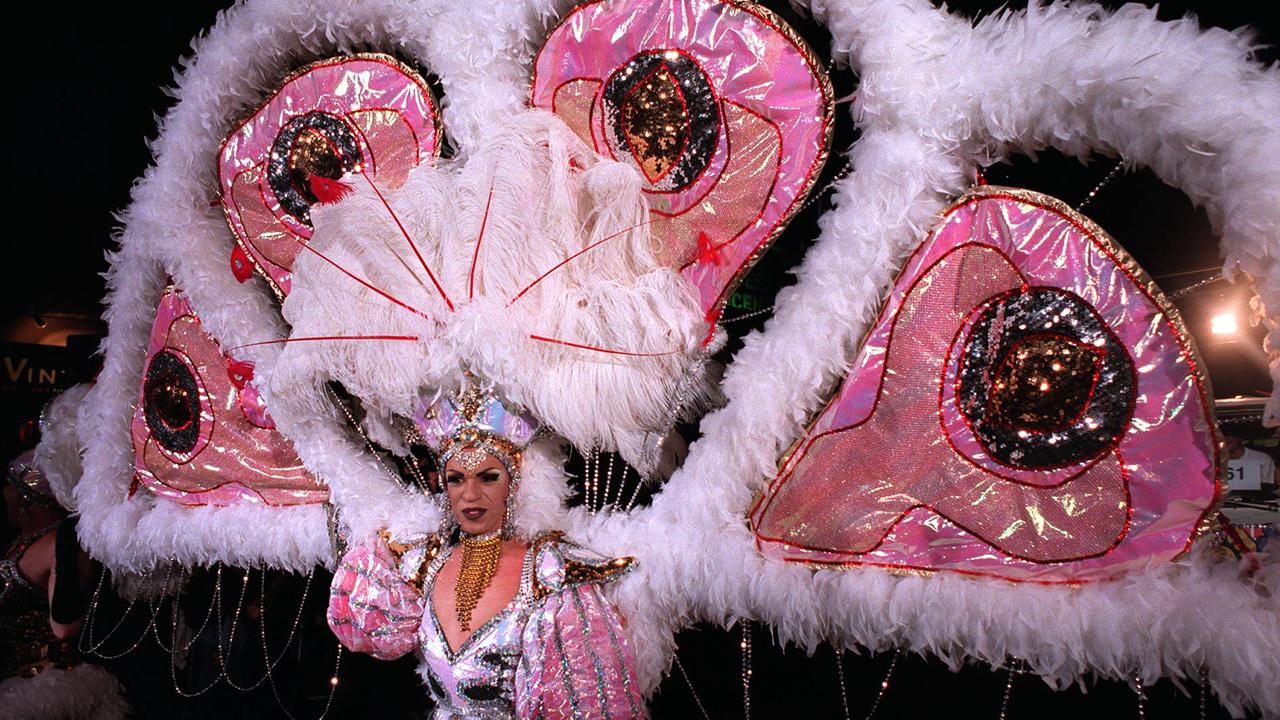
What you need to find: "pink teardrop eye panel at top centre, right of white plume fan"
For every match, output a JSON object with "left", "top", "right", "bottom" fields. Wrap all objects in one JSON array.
[{"left": 532, "top": 0, "right": 833, "bottom": 319}]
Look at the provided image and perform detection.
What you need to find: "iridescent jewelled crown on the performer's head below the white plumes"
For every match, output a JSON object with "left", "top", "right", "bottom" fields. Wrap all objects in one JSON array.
[{"left": 413, "top": 383, "right": 539, "bottom": 479}]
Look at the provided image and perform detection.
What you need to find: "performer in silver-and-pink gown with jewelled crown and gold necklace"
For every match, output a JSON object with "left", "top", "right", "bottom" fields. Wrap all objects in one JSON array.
[{"left": 329, "top": 384, "right": 645, "bottom": 720}]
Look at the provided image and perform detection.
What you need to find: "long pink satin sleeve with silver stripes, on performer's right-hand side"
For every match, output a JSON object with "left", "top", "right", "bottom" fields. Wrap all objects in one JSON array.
[{"left": 516, "top": 585, "right": 645, "bottom": 720}]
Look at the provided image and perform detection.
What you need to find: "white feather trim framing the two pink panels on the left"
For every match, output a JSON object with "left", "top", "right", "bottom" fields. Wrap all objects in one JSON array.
[{"left": 74, "top": 0, "right": 556, "bottom": 571}]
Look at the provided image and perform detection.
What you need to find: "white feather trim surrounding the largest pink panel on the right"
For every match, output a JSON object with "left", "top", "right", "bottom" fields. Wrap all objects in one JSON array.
[{"left": 575, "top": 0, "right": 1280, "bottom": 715}]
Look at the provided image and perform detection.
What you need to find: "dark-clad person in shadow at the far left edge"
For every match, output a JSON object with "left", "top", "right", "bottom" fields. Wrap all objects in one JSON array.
[{"left": 0, "top": 451, "right": 129, "bottom": 720}]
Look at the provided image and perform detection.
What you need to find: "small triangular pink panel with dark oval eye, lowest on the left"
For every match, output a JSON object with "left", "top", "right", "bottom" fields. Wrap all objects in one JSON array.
[{"left": 131, "top": 288, "right": 329, "bottom": 506}]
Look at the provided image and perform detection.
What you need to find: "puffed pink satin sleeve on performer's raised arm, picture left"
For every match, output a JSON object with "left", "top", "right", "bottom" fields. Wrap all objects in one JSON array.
[{"left": 329, "top": 541, "right": 424, "bottom": 660}]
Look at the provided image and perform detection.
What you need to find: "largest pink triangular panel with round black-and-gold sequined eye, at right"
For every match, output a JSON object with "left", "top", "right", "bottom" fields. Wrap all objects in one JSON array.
[{"left": 751, "top": 187, "right": 1220, "bottom": 583}]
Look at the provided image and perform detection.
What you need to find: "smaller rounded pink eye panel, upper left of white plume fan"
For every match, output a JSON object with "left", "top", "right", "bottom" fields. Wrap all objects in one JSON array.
[{"left": 218, "top": 54, "right": 440, "bottom": 299}]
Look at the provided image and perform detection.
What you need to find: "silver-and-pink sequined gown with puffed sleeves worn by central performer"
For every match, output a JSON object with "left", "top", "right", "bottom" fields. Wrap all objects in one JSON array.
[{"left": 329, "top": 536, "right": 645, "bottom": 720}]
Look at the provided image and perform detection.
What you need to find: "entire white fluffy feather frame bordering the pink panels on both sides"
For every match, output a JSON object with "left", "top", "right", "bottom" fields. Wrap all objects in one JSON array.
[{"left": 57, "top": 0, "right": 1280, "bottom": 714}]
